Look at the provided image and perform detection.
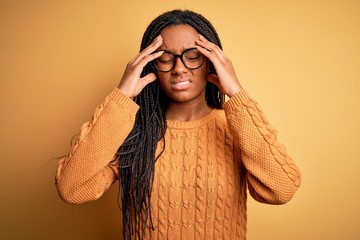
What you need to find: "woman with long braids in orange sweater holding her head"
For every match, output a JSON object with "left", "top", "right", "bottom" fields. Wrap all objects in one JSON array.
[{"left": 56, "top": 10, "right": 300, "bottom": 239}]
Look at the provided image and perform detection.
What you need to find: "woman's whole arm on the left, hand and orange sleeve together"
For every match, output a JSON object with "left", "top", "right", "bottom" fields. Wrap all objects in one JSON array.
[{"left": 56, "top": 36, "right": 163, "bottom": 203}]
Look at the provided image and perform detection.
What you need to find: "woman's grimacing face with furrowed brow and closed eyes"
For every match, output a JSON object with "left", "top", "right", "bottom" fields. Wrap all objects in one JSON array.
[{"left": 158, "top": 25, "right": 207, "bottom": 103}]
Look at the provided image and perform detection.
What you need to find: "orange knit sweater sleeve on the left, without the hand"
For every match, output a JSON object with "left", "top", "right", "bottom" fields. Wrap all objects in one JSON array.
[{"left": 55, "top": 88, "right": 139, "bottom": 204}]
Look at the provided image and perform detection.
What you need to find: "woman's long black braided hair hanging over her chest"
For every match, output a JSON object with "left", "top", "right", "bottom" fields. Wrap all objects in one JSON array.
[{"left": 116, "top": 10, "right": 225, "bottom": 239}]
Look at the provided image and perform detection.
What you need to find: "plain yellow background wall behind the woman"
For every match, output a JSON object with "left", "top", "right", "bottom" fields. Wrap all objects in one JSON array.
[{"left": 0, "top": 0, "right": 360, "bottom": 240}]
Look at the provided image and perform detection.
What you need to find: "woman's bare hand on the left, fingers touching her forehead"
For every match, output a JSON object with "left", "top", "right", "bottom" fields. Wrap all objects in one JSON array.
[{"left": 118, "top": 35, "right": 163, "bottom": 98}]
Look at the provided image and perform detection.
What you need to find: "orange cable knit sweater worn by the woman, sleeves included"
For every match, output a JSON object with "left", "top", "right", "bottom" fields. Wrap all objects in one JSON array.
[{"left": 56, "top": 89, "right": 301, "bottom": 240}]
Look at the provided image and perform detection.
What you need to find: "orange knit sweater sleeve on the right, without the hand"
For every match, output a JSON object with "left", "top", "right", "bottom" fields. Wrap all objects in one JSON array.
[{"left": 224, "top": 90, "right": 301, "bottom": 204}]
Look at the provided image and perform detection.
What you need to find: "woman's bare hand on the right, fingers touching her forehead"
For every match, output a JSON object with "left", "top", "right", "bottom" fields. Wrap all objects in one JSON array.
[{"left": 195, "top": 35, "right": 242, "bottom": 97}]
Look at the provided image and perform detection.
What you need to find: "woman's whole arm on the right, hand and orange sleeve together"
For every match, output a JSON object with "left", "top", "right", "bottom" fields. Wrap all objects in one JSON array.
[{"left": 195, "top": 36, "right": 301, "bottom": 204}]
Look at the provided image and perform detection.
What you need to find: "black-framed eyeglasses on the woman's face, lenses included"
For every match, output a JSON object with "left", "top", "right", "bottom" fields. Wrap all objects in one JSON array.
[{"left": 154, "top": 48, "right": 205, "bottom": 72}]
